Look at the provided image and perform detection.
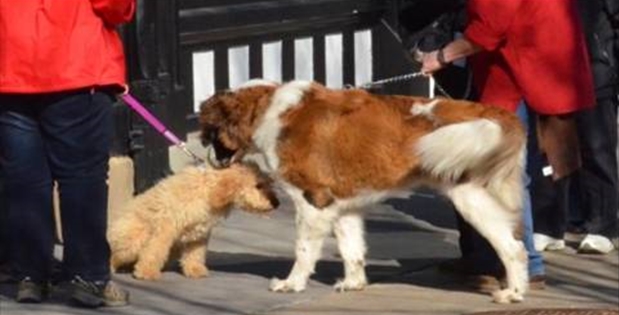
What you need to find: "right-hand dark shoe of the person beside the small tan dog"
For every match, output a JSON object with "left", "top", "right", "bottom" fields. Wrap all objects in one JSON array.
[{"left": 69, "top": 276, "right": 129, "bottom": 308}]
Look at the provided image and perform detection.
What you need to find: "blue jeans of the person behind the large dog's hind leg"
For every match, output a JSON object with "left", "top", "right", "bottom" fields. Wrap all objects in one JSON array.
[{"left": 458, "top": 104, "right": 545, "bottom": 276}]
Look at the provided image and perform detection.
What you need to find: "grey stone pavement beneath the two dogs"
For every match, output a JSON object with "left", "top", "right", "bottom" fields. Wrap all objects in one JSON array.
[{"left": 0, "top": 190, "right": 619, "bottom": 315}]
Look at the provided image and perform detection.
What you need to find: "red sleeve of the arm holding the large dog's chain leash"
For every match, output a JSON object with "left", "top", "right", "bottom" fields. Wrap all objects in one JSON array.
[{"left": 464, "top": 0, "right": 532, "bottom": 50}]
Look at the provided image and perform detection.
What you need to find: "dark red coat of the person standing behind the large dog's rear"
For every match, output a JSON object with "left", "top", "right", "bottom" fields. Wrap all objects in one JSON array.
[{"left": 465, "top": 0, "right": 595, "bottom": 114}]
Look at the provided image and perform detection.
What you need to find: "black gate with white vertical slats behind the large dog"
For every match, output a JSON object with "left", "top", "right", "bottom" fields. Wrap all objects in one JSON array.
[{"left": 114, "top": 0, "right": 427, "bottom": 191}]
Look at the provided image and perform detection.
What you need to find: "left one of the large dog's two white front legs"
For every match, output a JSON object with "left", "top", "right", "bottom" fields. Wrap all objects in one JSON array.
[{"left": 270, "top": 197, "right": 335, "bottom": 292}]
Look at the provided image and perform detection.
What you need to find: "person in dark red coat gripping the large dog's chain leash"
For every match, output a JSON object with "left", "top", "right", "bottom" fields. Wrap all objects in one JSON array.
[{"left": 420, "top": 0, "right": 595, "bottom": 286}]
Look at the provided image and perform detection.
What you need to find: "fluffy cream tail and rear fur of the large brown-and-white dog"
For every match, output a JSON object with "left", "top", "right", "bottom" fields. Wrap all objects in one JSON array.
[{"left": 416, "top": 119, "right": 526, "bottom": 214}]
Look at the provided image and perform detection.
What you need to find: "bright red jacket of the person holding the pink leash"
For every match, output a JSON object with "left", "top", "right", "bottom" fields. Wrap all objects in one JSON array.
[{"left": 0, "top": 0, "right": 135, "bottom": 93}]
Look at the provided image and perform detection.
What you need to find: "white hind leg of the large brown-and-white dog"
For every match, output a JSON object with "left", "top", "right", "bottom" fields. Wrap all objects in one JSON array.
[{"left": 447, "top": 183, "right": 529, "bottom": 303}]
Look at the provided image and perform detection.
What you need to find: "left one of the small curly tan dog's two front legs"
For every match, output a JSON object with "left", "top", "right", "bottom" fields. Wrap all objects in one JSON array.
[{"left": 133, "top": 222, "right": 176, "bottom": 280}]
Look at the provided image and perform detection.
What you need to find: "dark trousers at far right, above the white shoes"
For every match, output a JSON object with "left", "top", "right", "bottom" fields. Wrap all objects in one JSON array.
[{"left": 532, "top": 99, "right": 619, "bottom": 238}]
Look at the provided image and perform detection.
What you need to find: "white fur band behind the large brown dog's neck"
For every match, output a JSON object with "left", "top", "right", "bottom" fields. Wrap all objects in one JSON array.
[{"left": 252, "top": 81, "right": 312, "bottom": 172}]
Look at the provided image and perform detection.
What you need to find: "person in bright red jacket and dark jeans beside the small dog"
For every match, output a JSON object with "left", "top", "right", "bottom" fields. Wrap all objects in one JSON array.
[{"left": 0, "top": 0, "right": 135, "bottom": 307}]
